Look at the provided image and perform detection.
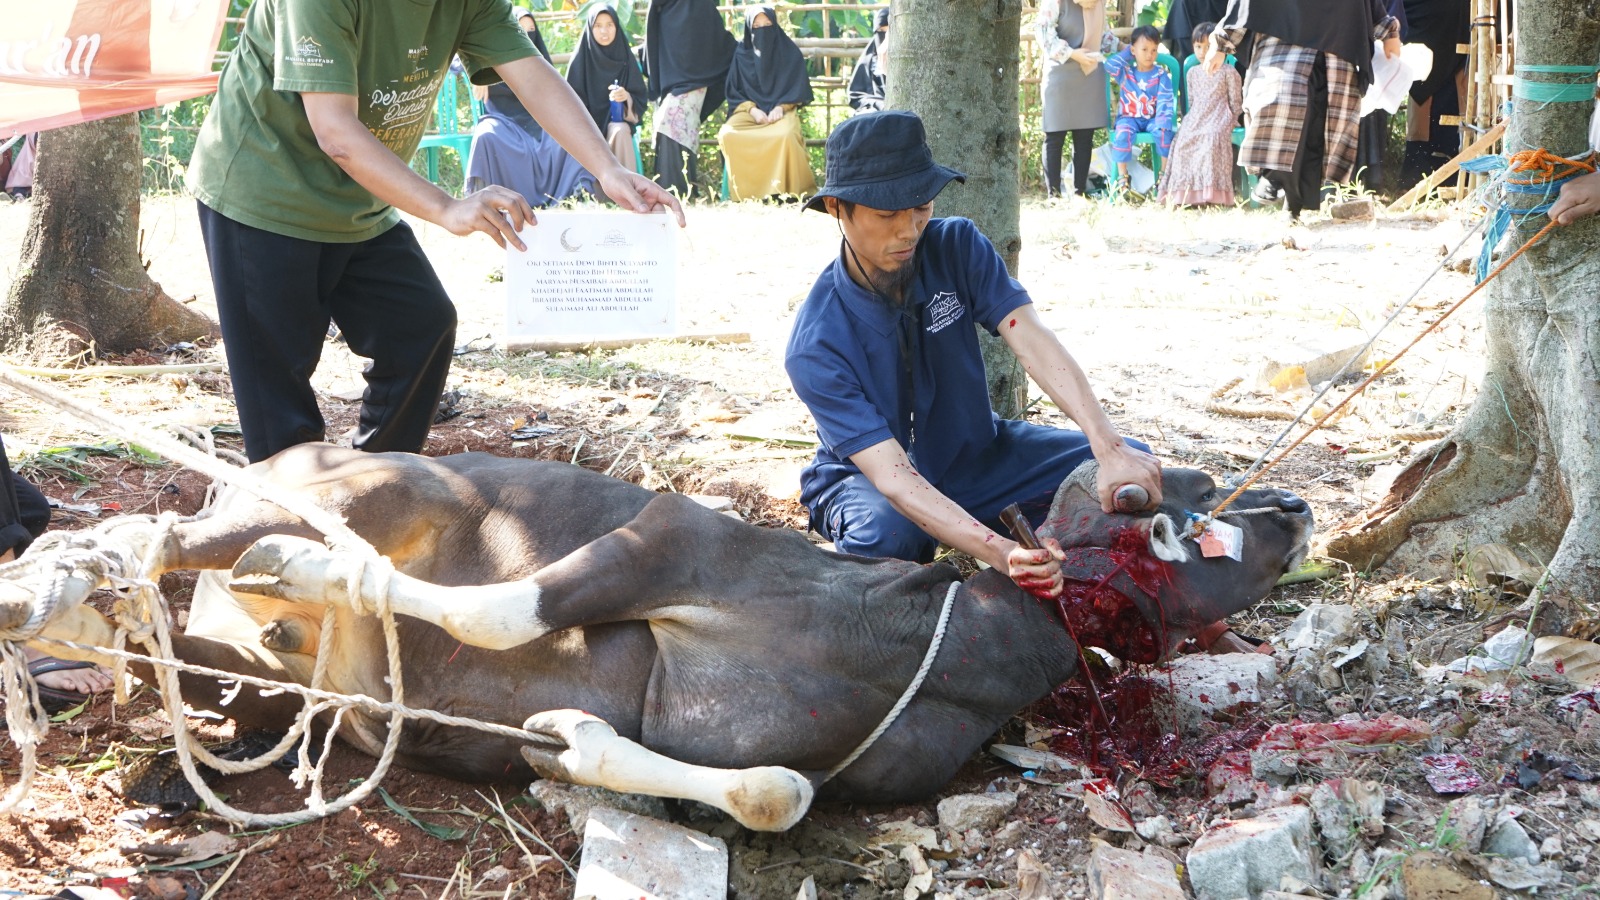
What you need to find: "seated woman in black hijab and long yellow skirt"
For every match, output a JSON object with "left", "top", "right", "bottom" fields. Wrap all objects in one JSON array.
[{"left": 717, "top": 6, "right": 816, "bottom": 200}]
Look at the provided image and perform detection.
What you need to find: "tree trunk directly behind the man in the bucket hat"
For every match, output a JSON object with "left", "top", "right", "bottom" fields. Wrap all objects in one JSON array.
[{"left": 888, "top": 0, "right": 1027, "bottom": 418}]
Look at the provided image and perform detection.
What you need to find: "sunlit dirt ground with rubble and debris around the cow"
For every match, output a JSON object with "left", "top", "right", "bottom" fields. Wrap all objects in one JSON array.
[{"left": 0, "top": 190, "right": 1600, "bottom": 900}]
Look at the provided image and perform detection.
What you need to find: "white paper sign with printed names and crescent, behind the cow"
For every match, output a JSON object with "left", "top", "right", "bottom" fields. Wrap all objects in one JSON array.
[{"left": 506, "top": 211, "right": 678, "bottom": 341}]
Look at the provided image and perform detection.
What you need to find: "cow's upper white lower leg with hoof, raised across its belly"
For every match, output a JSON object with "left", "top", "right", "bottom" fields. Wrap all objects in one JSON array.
[{"left": 227, "top": 535, "right": 554, "bottom": 650}]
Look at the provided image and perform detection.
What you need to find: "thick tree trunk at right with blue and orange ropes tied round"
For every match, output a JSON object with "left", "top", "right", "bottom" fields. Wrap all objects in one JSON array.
[{"left": 1328, "top": 2, "right": 1600, "bottom": 629}]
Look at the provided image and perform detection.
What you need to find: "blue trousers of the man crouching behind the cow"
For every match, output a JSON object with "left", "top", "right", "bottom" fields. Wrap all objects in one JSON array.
[{"left": 811, "top": 420, "right": 1149, "bottom": 562}]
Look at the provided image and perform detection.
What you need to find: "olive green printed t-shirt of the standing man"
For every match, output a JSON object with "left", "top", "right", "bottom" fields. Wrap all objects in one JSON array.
[{"left": 187, "top": 0, "right": 534, "bottom": 242}]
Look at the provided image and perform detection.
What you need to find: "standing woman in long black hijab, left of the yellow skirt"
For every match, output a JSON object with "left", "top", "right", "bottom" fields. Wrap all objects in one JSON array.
[{"left": 645, "top": 0, "right": 736, "bottom": 195}]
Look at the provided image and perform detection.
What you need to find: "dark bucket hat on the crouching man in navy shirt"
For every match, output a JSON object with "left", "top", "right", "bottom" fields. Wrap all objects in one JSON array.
[{"left": 805, "top": 109, "right": 966, "bottom": 210}]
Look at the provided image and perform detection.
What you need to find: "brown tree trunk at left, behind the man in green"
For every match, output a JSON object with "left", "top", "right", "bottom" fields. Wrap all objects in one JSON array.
[{"left": 0, "top": 115, "right": 218, "bottom": 359}]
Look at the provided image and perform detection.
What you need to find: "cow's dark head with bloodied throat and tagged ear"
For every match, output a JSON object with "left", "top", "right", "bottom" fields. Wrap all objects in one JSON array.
[{"left": 1038, "top": 461, "right": 1312, "bottom": 663}]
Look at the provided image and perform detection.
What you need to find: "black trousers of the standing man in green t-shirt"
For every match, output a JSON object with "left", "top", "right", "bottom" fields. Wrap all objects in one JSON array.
[{"left": 200, "top": 203, "right": 456, "bottom": 463}]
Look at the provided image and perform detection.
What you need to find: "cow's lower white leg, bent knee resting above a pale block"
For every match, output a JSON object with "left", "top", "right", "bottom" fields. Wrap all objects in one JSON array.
[{"left": 522, "top": 709, "right": 814, "bottom": 831}]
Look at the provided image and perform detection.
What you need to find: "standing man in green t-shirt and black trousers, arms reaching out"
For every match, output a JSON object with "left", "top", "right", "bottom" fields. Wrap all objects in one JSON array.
[{"left": 187, "top": 0, "right": 683, "bottom": 461}]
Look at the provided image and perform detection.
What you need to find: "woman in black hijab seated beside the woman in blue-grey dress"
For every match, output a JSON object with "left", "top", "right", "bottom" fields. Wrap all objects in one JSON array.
[{"left": 566, "top": 5, "right": 645, "bottom": 168}]
